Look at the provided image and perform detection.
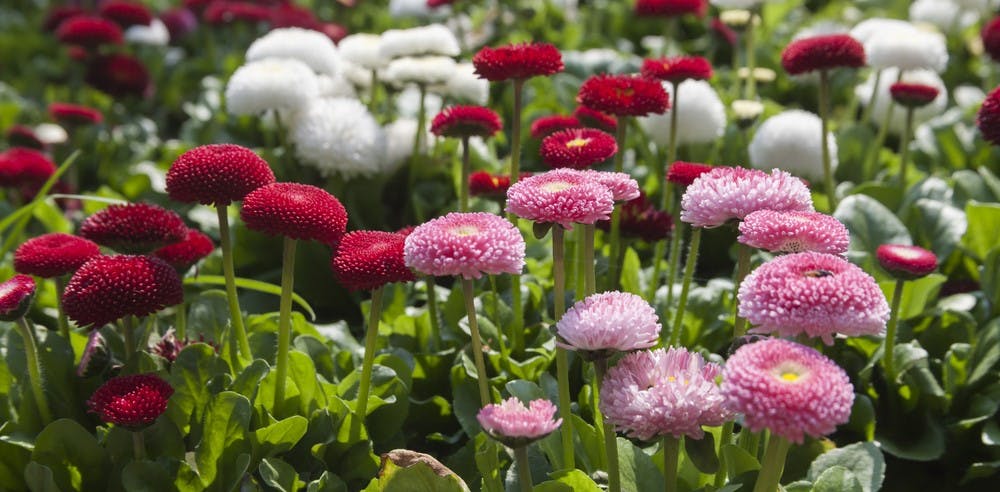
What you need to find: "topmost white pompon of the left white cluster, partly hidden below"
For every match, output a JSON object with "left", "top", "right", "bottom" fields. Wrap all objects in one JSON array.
[{"left": 246, "top": 27, "right": 338, "bottom": 75}]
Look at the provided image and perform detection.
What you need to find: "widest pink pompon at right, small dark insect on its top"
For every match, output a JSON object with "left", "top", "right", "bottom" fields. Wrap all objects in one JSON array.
[{"left": 737, "top": 252, "right": 889, "bottom": 345}]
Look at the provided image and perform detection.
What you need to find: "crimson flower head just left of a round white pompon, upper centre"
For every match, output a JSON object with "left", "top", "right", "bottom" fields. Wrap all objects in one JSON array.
[{"left": 576, "top": 74, "right": 670, "bottom": 116}]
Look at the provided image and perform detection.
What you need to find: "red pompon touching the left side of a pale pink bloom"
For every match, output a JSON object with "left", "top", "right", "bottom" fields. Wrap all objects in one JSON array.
[{"left": 331, "top": 231, "right": 416, "bottom": 291}]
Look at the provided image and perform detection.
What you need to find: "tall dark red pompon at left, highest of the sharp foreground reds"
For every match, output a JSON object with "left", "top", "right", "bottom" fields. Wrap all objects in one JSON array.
[{"left": 167, "top": 144, "right": 274, "bottom": 206}]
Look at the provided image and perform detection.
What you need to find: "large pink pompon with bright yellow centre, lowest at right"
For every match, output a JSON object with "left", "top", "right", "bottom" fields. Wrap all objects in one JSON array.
[{"left": 722, "top": 338, "right": 854, "bottom": 444}]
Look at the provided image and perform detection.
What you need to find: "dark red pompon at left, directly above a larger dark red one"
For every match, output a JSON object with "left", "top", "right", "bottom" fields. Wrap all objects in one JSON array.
[{"left": 80, "top": 203, "right": 187, "bottom": 254}]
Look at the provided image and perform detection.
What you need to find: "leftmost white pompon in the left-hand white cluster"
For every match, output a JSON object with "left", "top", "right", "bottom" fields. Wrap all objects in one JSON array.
[{"left": 226, "top": 58, "right": 319, "bottom": 115}]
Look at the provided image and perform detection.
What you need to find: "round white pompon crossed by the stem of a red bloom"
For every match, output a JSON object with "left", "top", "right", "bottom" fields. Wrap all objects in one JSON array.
[{"left": 749, "top": 109, "right": 837, "bottom": 181}]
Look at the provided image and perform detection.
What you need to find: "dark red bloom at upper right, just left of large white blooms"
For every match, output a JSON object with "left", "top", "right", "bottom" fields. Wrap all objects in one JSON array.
[{"left": 781, "top": 34, "right": 865, "bottom": 75}]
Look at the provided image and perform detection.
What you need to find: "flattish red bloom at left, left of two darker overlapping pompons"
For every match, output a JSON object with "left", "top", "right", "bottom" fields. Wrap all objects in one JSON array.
[{"left": 14, "top": 232, "right": 101, "bottom": 278}]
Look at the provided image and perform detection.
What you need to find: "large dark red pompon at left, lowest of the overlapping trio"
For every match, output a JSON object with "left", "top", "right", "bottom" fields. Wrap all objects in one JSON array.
[{"left": 62, "top": 255, "right": 184, "bottom": 328}]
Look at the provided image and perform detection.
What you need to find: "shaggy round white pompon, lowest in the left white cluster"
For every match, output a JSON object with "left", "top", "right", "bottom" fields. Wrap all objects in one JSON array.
[{"left": 289, "top": 98, "right": 385, "bottom": 178}]
